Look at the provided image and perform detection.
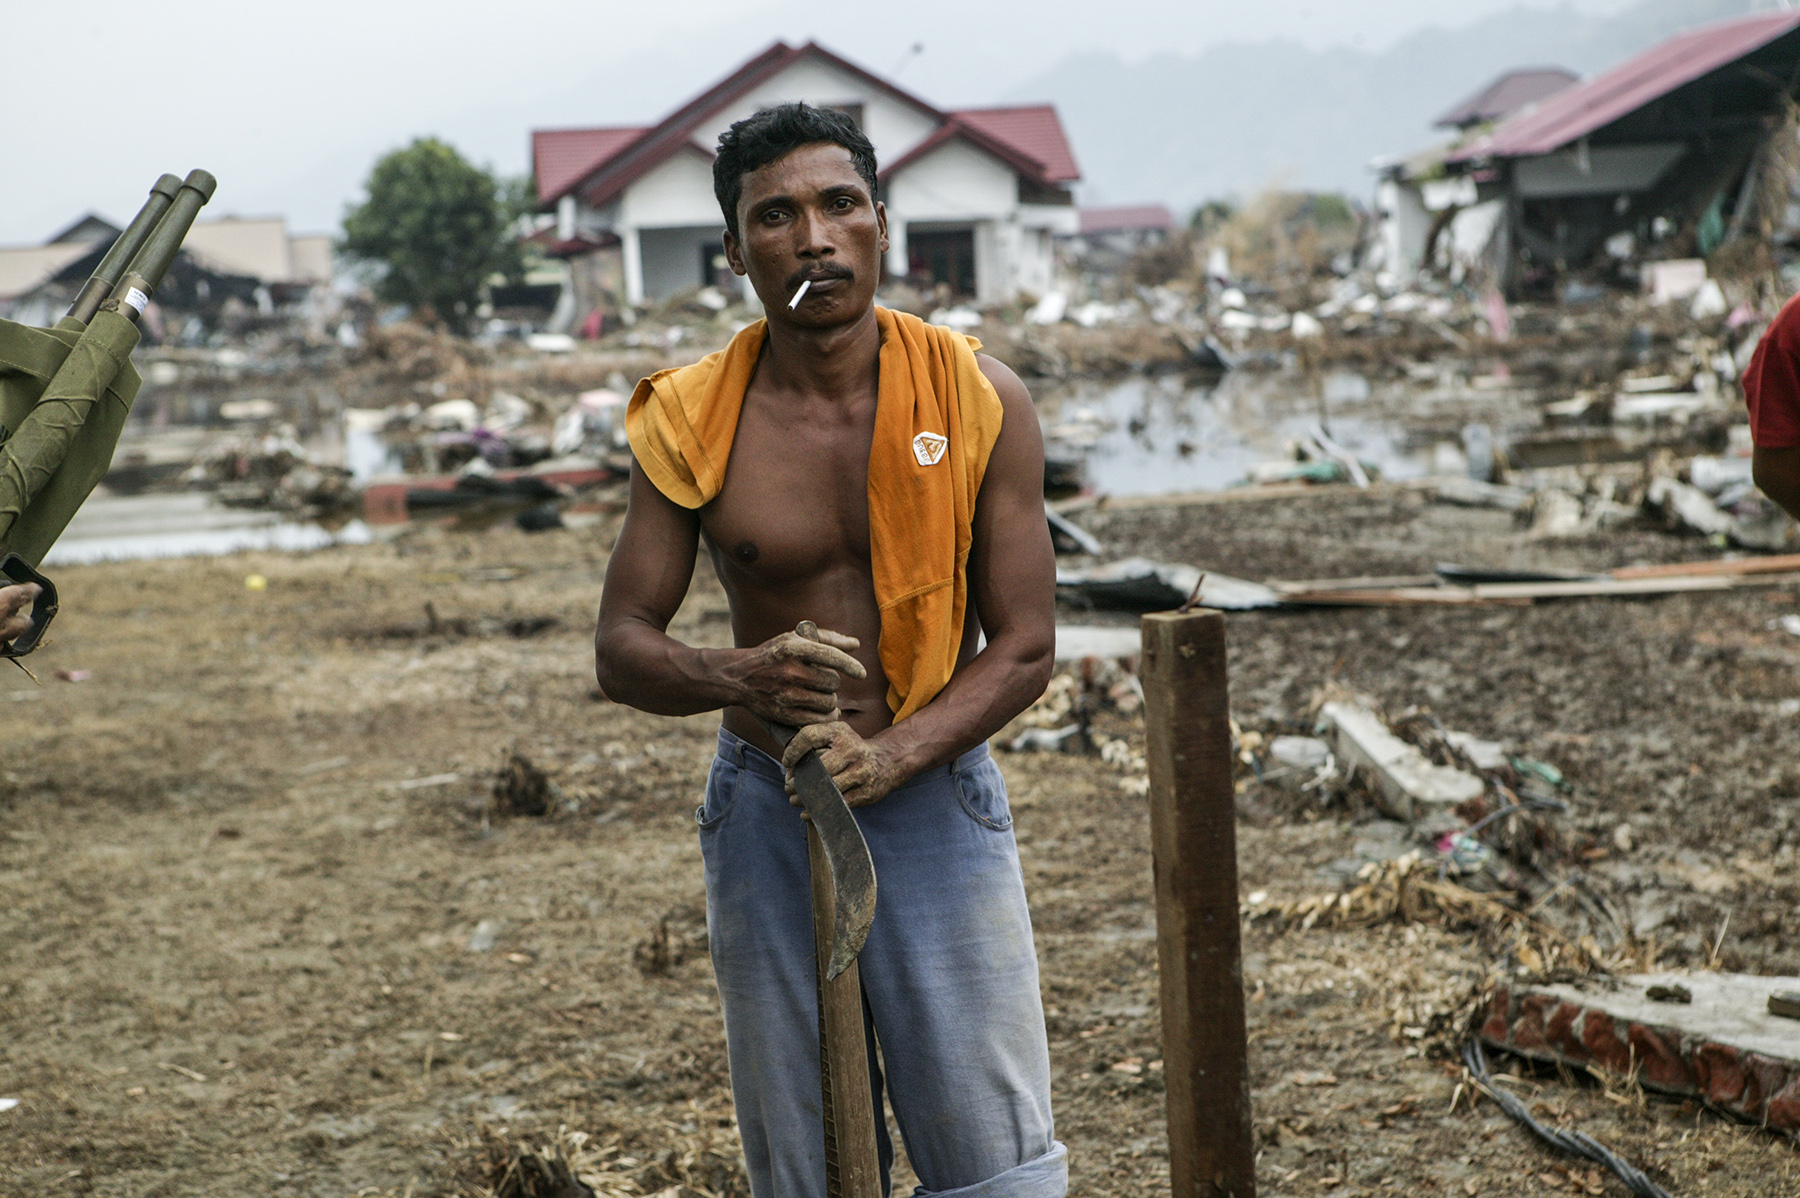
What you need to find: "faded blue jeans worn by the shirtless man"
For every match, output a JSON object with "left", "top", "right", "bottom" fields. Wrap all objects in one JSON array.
[{"left": 698, "top": 729, "right": 1069, "bottom": 1198}]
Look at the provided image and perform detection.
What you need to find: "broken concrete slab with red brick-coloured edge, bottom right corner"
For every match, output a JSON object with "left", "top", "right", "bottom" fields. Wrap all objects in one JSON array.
[{"left": 1481, "top": 973, "right": 1800, "bottom": 1131}]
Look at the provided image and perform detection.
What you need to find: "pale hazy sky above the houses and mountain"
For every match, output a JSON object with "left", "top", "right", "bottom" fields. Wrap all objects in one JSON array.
[{"left": 0, "top": 0, "right": 1625, "bottom": 245}]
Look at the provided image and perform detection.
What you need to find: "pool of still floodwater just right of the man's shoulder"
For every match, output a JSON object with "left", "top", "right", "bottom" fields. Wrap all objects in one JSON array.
[{"left": 1039, "top": 372, "right": 1431, "bottom": 495}]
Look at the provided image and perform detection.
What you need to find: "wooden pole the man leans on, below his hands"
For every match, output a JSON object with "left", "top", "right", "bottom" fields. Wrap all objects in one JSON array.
[{"left": 806, "top": 822, "right": 882, "bottom": 1198}]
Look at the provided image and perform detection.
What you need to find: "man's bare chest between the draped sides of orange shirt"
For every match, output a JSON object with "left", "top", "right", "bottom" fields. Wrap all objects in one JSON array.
[{"left": 700, "top": 403, "right": 875, "bottom": 583}]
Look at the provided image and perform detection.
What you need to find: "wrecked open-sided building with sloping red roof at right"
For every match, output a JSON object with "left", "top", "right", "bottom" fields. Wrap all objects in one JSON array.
[{"left": 1377, "top": 11, "right": 1800, "bottom": 295}]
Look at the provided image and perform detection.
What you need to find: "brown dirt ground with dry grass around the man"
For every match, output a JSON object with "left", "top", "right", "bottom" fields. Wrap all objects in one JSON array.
[{"left": 0, "top": 491, "right": 1800, "bottom": 1198}]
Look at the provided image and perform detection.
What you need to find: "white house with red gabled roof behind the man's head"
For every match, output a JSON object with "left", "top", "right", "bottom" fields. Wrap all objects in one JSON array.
[{"left": 531, "top": 41, "right": 1082, "bottom": 312}]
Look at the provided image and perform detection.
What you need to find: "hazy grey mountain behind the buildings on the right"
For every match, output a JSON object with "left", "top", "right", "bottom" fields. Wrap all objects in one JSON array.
[{"left": 1008, "top": 0, "right": 1769, "bottom": 212}]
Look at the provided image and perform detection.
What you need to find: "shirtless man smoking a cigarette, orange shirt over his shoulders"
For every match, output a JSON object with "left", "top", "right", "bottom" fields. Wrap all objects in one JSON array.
[{"left": 596, "top": 104, "right": 1067, "bottom": 1198}]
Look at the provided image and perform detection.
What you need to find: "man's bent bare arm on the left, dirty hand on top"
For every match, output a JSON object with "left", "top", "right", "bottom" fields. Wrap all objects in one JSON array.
[{"left": 594, "top": 462, "right": 864, "bottom": 727}]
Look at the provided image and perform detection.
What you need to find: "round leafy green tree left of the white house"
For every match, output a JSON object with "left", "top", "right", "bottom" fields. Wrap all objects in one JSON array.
[{"left": 338, "top": 137, "right": 522, "bottom": 333}]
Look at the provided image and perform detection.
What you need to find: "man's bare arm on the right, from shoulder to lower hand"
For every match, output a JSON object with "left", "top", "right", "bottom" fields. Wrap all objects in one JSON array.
[{"left": 783, "top": 354, "right": 1057, "bottom": 806}]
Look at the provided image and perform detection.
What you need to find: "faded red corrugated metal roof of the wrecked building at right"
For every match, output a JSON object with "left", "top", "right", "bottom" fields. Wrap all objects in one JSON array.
[{"left": 1447, "top": 11, "right": 1800, "bottom": 162}]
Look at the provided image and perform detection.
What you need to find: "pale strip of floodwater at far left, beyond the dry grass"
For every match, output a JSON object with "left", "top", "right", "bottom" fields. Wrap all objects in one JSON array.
[{"left": 43, "top": 491, "right": 373, "bottom": 567}]
